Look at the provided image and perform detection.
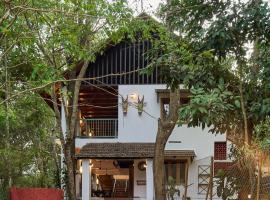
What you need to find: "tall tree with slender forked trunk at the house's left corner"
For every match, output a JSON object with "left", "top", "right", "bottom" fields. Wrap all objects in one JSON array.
[{"left": 1, "top": 0, "right": 131, "bottom": 200}]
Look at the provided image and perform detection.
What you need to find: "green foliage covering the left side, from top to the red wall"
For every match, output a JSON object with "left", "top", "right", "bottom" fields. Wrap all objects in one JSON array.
[{"left": 0, "top": 0, "right": 135, "bottom": 198}]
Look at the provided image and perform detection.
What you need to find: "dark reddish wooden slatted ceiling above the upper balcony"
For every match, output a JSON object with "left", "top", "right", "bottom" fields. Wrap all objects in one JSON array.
[{"left": 79, "top": 86, "right": 118, "bottom": 118}]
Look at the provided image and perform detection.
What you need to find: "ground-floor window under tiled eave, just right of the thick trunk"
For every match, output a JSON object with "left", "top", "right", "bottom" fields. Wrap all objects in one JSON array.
[{"left": 165, "top": 160, "right": 186, "bottom": 185}]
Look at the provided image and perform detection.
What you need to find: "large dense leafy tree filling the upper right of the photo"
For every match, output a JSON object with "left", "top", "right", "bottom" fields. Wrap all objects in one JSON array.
[{"left": 150, "top": 0, "right": 270, "bottom": 199}]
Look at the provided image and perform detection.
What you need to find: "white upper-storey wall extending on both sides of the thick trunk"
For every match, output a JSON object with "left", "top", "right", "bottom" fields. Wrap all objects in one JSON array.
[{"left": 76, "top": 85, "right": 225, "bottom": 147}]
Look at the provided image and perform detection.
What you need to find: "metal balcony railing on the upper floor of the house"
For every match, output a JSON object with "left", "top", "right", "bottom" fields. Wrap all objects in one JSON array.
[{"left": 81, "top": 118, "right": 118, "bottom": 138}]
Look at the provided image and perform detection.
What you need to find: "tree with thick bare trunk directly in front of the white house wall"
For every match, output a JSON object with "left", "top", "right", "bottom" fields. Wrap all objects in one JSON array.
[{"left": 144, "top": 18, "right": 212, "bottom": 200}]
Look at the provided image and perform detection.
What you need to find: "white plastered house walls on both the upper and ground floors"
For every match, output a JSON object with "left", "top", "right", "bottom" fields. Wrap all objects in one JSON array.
[{"left": 76, "top": 85, "right": 226, "bottom": 200}]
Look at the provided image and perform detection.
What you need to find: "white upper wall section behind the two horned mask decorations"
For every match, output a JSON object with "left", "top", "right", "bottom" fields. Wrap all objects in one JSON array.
[{"left": 118, "top": 85, "right": 162, "bottom": 142}]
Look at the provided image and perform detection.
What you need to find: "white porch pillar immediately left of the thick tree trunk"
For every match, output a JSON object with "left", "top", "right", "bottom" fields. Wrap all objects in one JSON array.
[{"left": 146, "top": 159, "right": 154, "bottom": 200}]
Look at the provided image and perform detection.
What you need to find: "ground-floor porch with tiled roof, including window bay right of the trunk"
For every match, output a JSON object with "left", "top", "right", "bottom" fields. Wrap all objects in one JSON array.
[{"left": 76, "top": 143, "right": 195, "bottom": 200}]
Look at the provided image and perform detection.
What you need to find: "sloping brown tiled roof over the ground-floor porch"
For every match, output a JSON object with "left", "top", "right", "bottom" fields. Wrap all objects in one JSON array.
[{"left": 76, "top": 143, "right": 196, "bottom": 159}]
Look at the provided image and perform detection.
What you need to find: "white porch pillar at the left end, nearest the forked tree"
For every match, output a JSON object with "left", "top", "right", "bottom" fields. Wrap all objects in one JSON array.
[{"left": 82, "top": 159, "right": 91, "bottom": 200}]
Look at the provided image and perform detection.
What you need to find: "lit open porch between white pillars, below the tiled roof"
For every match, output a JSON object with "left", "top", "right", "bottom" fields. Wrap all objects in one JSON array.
[{"left": 76, "top": 159, "right": 153, "bottom": 200}]
